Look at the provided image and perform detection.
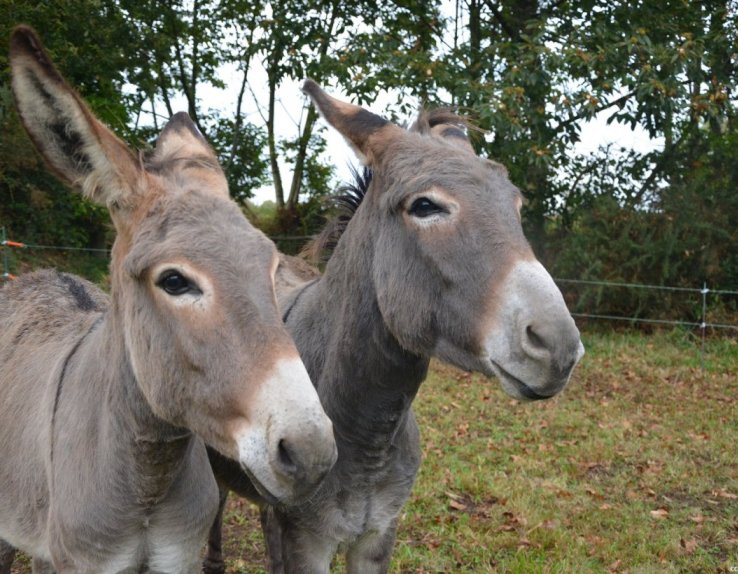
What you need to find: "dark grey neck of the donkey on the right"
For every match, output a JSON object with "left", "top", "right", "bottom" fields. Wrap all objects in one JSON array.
[{"left": 287, "top": 228, "right": 429, "bottom": 464}]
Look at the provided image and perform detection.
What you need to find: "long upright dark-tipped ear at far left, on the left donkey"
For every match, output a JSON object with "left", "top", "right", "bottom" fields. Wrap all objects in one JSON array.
[{"left": 10, "top": 26, "right": 142, "bottom": 212}]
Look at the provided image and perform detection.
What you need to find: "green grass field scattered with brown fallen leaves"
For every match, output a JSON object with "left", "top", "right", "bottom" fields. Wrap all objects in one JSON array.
[{"left": 7, "top": 331, "right": 738, "bottom": 574}]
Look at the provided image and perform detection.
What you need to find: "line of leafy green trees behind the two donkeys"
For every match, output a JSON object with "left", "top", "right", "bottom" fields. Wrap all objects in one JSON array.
[{"left": 0, "top": 0, "right": 738, "bottom": 317}]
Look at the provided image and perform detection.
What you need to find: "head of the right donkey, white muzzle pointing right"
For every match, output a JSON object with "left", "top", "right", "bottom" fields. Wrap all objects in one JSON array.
[{"left": 303, "top": 80, "right": 584, "bottom": 399}]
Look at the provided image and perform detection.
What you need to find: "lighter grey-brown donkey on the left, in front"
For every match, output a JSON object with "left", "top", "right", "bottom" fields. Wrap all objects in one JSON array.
[{"left": 0, "top": 26, "right": 336, "bottom": 574}]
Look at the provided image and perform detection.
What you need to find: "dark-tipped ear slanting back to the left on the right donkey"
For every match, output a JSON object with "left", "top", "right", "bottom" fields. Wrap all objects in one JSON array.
[{"left": 302, "top": 79, "right": 404, "bottom": 165}]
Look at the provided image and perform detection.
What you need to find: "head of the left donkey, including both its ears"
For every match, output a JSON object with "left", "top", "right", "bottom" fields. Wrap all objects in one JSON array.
[{"left": 10, "top": 27, "right": 336, "bottom": 499}]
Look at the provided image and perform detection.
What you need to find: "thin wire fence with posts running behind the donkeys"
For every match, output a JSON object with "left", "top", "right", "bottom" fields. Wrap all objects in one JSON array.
[{"left": 0, "top": 227, "right": 738, "bottom": 361}]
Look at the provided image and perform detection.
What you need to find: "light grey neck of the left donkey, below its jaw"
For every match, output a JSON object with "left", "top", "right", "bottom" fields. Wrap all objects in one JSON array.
[{"left": 58, "top": 304, "right": 194, "bottom": 509}]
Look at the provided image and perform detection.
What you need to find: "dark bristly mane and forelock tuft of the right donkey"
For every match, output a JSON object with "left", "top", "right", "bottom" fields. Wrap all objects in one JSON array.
[{"left": 302, "top": 108, "right": 474, "bottom": 264}]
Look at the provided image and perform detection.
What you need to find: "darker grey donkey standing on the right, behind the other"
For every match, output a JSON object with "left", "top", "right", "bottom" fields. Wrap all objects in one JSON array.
[{"left": 206, "top": 81, "right": 584, "bottom": 574}]
